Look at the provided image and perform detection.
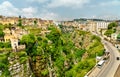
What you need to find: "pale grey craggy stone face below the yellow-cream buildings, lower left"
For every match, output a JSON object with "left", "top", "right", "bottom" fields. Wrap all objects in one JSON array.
[{"left": 8, "top": 52, "right": 32, "bottom": 77}]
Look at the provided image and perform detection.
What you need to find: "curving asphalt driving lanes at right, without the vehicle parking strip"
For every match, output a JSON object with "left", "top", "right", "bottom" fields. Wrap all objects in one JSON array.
[{"left": 96, "top": 40, "right": 120, "bottom": 77}]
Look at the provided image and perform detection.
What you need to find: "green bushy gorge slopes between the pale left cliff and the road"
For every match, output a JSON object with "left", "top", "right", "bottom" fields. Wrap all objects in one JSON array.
[{"left": 21, "top": 26, "right": 104, "bottom": 77}]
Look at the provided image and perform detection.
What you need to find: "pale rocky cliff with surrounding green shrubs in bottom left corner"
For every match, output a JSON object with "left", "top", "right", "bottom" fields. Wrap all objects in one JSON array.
[{"left": 0, "top": 51, "right": 33, "bottom": 77}]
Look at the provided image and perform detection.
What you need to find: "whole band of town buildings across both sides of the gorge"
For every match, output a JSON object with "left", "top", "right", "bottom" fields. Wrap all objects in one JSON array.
[{"left": 0, "top": 16, "right": 120, "bottom": 49}]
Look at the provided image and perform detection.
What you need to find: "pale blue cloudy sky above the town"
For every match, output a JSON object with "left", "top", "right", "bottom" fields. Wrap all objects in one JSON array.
[{"left": 0, "top": 0, "right": 120, "bottom": 20}]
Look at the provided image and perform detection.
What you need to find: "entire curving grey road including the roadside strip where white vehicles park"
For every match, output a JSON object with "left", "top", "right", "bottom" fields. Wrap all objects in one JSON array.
[{"left": 88, "top": 33, "right": 120, "bottom": 77}]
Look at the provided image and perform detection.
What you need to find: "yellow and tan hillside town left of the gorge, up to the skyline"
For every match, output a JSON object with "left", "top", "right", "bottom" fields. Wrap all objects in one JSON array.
[{"left": 0, "top": 16, "right": 54, "bottom": 50}]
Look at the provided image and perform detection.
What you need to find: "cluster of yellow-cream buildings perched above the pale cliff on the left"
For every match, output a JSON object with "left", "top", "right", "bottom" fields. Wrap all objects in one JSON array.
[{"left": 4, "top": 27, "right": 28, "bottom": 50}]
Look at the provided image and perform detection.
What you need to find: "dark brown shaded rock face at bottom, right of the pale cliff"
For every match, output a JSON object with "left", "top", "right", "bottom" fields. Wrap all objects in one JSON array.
[{"left": 29, "top": 55, "right": 49, "bottom": 77}]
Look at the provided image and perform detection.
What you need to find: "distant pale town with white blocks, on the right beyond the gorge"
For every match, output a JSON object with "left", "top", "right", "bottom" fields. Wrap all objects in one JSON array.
[{"left": 57, "top": 19, "right": 120, "bottom": 43}]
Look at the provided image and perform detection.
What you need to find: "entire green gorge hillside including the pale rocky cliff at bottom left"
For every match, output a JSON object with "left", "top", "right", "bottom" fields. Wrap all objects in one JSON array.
[{"left": 0, "top": 25, "right": 104, "bottom": 77}]
